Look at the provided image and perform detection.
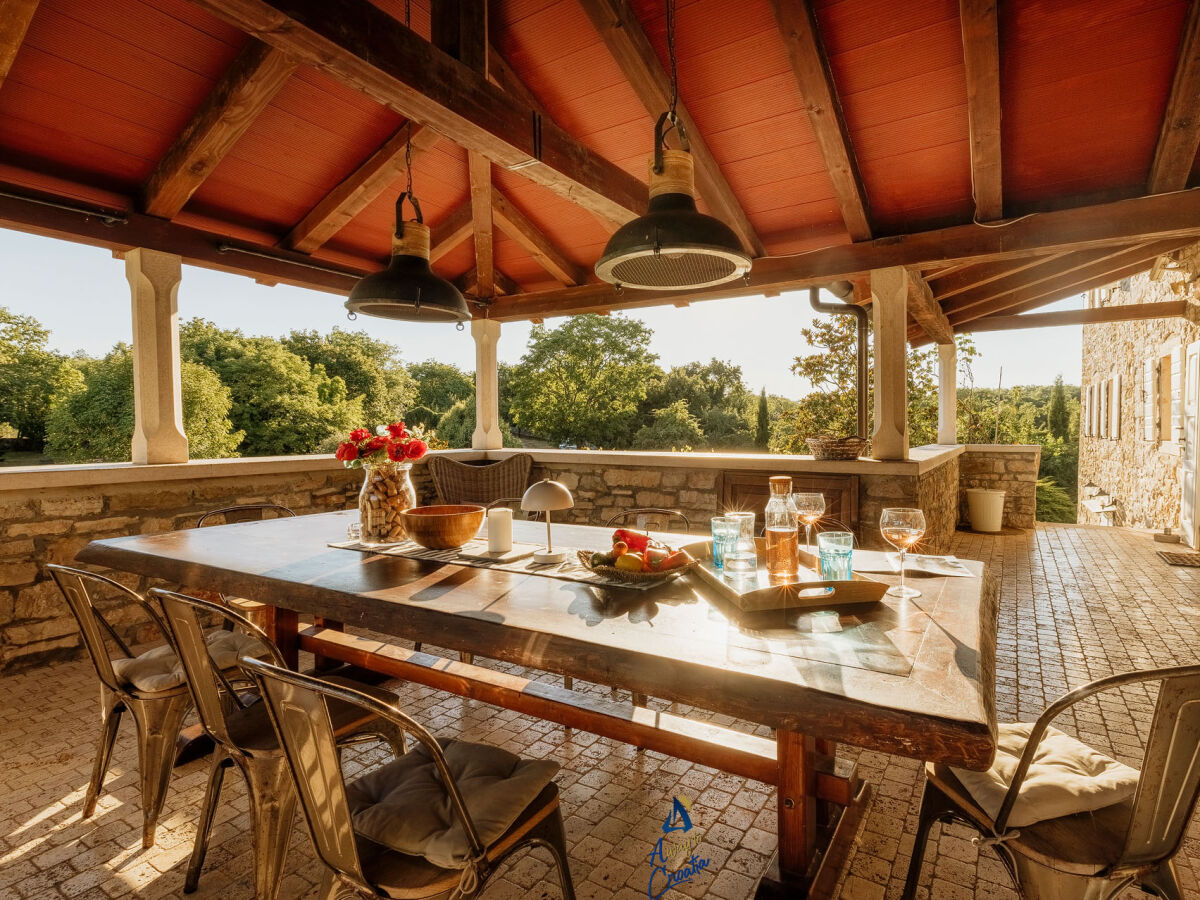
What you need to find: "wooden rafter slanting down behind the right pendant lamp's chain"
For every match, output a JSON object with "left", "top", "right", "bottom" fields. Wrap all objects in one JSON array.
[{"left": 581, "top": 0, "right": 767, "bottom": 257}]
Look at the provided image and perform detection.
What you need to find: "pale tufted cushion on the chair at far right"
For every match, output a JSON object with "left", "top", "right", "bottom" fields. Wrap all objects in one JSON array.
[{"left": 953, "top": 722, "right": 1139, "bottom": 828}]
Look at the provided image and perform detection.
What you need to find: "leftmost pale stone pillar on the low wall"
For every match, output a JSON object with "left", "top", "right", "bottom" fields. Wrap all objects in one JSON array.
[{"left": 125, "top": 247, "right": 187, "bottom": 464}]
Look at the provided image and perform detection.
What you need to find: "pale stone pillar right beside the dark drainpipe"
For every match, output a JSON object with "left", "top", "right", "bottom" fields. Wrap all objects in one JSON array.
[{"left": 871, "top": 266, "right": 908, "bottom": 460}]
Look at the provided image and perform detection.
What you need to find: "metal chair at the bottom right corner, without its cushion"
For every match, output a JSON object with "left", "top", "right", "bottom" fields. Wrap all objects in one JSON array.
[{"left": 902, "top": 666, "right": 1200, "bottom": 900}]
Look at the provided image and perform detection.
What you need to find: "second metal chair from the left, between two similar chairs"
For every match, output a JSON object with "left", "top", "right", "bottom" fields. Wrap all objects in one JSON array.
[{"left": 150, "top": 588, "right": 404, "bottom": 900}]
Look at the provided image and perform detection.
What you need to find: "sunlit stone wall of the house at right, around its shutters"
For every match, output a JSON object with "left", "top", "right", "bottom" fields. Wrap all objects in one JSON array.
[{"left": 1079, "top": 245, "right": 1200, "bottom": 530}]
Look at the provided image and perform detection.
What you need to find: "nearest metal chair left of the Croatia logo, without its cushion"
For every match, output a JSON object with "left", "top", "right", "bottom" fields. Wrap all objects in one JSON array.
[{"left": 244, "top": 660, "right": 575, "bottom": 900}]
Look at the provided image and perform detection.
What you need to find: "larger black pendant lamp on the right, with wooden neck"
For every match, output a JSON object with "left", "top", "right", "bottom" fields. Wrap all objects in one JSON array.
[{"left": 595, "top": 113, "right": 750, "bottom": 290}]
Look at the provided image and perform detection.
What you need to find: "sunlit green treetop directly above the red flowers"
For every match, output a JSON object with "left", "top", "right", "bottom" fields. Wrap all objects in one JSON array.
[{"left": 283, "top": 328, "right": 416, "bottom": 425}]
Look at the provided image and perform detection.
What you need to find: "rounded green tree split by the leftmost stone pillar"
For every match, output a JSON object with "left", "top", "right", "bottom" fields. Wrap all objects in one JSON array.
[{"left": 46, "top": 343, "right": 242, "bottom": 462}]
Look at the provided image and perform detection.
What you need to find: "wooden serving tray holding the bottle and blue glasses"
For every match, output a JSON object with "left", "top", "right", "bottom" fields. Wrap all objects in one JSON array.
[{"left": 685, "top": 538, "right": 888, "bottom": 612}]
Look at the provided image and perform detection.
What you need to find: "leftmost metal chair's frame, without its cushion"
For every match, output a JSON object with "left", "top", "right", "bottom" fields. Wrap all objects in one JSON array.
[{"left": 46, "top": 565, "right": 192, "bottom": 847}]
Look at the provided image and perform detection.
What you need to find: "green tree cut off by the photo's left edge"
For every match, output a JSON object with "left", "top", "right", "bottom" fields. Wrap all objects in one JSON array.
[{"left": 0, "top": 306, "right": 68, "bottom": 448}]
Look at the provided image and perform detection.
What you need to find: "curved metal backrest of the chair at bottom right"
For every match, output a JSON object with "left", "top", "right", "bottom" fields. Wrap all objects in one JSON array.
[{"left": 996, "top": 666, "right": 1200, "bottom": 870}]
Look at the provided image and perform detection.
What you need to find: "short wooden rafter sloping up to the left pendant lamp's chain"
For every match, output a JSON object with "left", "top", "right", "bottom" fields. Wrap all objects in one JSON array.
[{"left": 281, "top": 122, "right": 442, "bottom": 253}]
